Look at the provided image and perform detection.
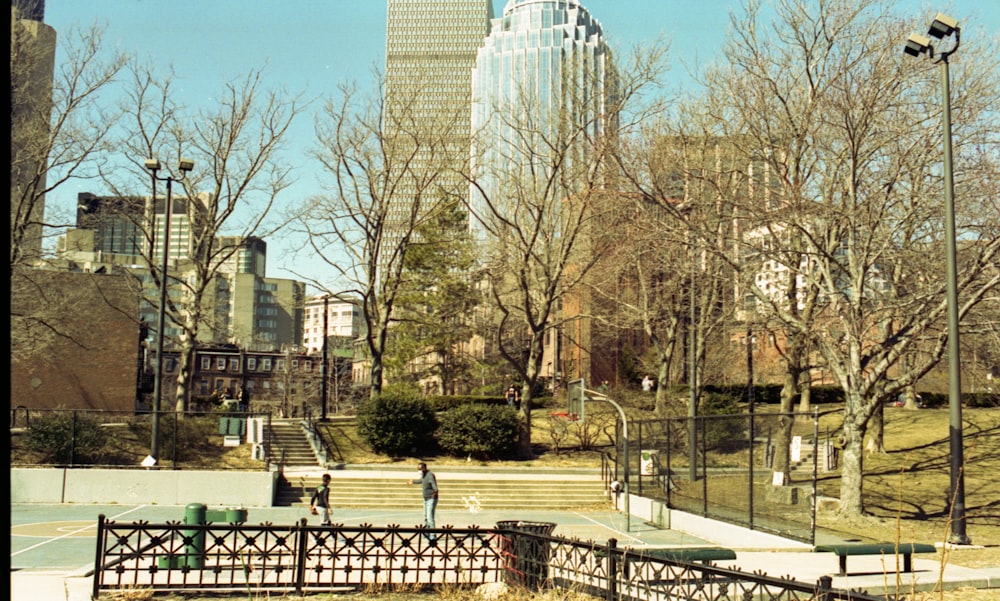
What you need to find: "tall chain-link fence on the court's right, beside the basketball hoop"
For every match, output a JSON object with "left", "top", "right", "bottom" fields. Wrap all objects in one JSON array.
[{"left": 616, "top": 412, "right": 836, "bottom": 544}]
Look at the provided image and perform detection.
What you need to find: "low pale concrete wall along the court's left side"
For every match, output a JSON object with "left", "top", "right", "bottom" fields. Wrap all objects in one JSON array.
[{"left": 10, "top": 468, "right": 278, "bottom": 507}]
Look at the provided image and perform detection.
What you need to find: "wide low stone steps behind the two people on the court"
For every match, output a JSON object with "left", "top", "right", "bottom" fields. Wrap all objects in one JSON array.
[{"left": 274, "top": 466, "right": 609, "bottom": 510}]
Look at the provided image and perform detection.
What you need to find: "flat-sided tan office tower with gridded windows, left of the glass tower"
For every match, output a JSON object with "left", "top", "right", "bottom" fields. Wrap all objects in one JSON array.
[{"left": 385, "top": 0, "right": 493, "bottom": 244}]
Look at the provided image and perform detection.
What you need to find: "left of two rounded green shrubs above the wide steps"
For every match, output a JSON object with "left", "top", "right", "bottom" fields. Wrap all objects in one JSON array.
[{"left": 358, "top": 388, "right": 437, "bottom": 457}]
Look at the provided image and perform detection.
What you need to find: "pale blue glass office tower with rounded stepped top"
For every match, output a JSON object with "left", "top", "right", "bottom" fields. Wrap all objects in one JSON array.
[{"left": 470, "top": 0, "right": 613, "bottom": 229}]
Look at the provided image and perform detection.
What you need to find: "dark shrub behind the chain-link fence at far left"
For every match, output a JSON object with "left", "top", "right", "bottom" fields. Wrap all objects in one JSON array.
[{"left": 24, "top": 413, "right": 108, "bottom": 463}]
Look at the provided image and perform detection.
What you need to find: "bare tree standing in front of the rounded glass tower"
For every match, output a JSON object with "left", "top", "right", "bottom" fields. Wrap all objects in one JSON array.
[{"left": 469, "top": 47, "right": 664, "bottom": 457}]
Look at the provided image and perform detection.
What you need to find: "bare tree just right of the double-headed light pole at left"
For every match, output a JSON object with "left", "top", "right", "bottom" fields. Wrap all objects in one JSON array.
[{"left": 105, "top": 63, "right": 302, "bottom": 413}]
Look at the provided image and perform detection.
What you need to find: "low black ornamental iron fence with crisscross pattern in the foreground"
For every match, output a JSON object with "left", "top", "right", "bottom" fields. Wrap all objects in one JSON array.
[{"left": 93, "top": 516, "right": 881, "bottom": 601}]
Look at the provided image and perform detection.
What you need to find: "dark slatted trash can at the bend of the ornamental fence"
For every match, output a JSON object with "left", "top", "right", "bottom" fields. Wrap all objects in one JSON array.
[{"left": 497, "top": 520, "right": 556, "bottom": 590}]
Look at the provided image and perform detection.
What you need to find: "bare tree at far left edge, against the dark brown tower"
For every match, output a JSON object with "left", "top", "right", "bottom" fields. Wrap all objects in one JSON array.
[{"left": 10, "top": 8, "right": 125, "bottom": 361}]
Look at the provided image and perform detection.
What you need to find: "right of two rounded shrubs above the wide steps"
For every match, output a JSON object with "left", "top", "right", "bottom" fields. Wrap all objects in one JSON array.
[{"left": 438, "top": 404, "right": 517, "bottom": 459}]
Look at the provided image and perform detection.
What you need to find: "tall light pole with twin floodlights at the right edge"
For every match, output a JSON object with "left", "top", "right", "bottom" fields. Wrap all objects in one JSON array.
[{"left": 903, "top": 13, "right": 971, "bottom": 545}]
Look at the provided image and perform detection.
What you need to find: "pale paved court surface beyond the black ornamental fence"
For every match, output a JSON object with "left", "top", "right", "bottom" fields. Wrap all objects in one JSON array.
[{"left": 10, "top": 504, "right": 1000, "bottom": 601}]
